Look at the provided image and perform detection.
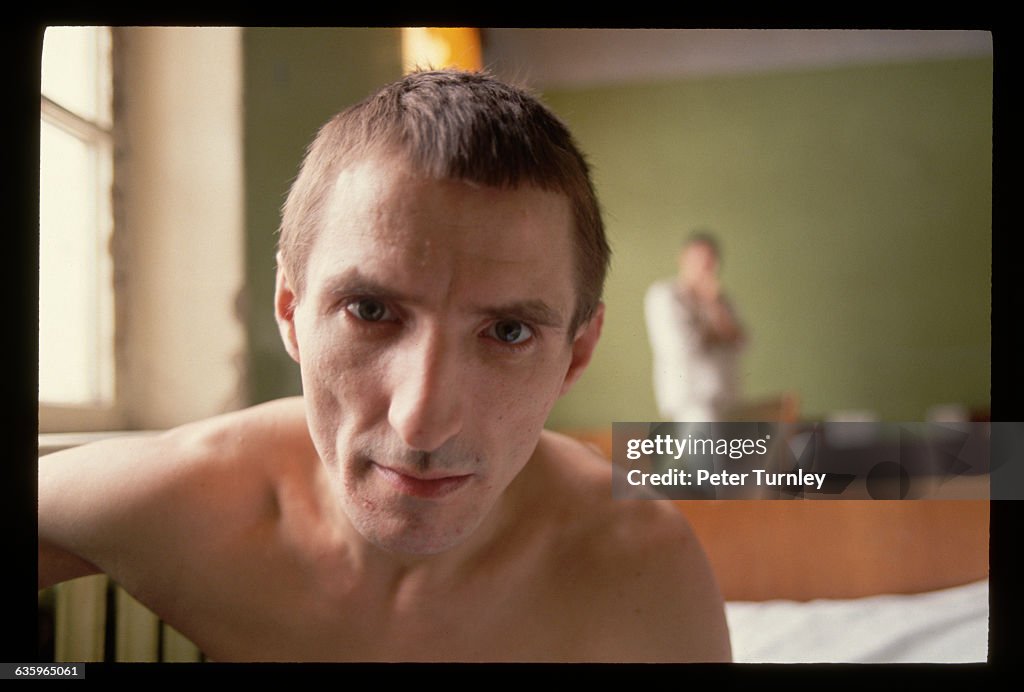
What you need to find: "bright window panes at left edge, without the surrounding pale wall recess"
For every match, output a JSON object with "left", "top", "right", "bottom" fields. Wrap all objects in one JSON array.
[{"left": 39, "top": 27, "right": 115, "bottom": 429}]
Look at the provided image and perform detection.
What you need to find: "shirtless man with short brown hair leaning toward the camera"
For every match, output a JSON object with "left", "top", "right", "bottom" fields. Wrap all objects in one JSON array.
[{"left": 39, "top": 73, "right": 730, "bottom": 661}]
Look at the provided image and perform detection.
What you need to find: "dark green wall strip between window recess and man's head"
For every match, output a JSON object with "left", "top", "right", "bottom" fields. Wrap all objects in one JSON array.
[{"left": 243, "top": 29, "right": 401, "bottom": 403}]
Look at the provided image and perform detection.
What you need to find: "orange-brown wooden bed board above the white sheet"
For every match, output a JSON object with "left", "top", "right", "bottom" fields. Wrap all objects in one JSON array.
[{"left": 671, "top": 500, "right": 989, "bottom": 601}]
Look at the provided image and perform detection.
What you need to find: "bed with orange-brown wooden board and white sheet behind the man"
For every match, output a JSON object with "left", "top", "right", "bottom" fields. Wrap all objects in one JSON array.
[{"left": 677, "top": 501, "right": 988, "bottom": 663}]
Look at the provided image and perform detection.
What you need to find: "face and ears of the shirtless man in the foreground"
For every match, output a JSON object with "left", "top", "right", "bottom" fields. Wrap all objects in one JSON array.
[{"left": 276, "top": 158, "right": 600, "bottom": 554}]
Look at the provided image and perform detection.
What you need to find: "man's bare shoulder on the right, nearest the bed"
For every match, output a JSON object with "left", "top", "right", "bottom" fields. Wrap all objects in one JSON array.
[{"left": 524, "top": 433, "right": 730, "bottom": 661}]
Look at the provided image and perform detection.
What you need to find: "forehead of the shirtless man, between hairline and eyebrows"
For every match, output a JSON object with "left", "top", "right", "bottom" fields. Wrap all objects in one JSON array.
[{"left": 311, "top": 155, "right": 574, "bottom": 312}]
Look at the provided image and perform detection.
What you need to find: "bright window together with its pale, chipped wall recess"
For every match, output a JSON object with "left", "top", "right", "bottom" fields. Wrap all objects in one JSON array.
[{"left": 39, "top": 27, "right": 247, "bottom": 433}]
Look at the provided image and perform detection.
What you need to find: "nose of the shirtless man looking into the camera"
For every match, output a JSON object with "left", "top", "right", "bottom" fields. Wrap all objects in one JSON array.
[{"left": 388, "top": 332, "right": 464, "bottom": 451}]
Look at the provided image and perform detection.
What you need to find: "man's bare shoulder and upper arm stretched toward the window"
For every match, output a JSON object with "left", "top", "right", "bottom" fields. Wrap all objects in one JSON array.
[{"left": 39, "top": 399, "right": 315, "bottom": 586}]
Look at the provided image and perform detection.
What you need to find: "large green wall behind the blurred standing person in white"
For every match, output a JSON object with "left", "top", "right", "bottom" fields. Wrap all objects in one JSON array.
[{"left": 545, "top": 59, "right": 992, "bottom": 427}]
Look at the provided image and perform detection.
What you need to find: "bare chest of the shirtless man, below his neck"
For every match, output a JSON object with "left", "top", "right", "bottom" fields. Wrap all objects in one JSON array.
[{"left": 140, "top": 456, "right": 610, "bottom": 661}]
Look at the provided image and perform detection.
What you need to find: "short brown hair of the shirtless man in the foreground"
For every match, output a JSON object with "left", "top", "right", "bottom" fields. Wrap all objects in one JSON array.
[{"left": 279, "top": 70, "right": 610, "bottom": 337}]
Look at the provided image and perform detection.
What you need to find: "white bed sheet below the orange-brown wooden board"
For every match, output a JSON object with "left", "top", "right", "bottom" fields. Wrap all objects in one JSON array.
[{"left": 725, "top": 580, "right": 988, "bottom": 663}]
